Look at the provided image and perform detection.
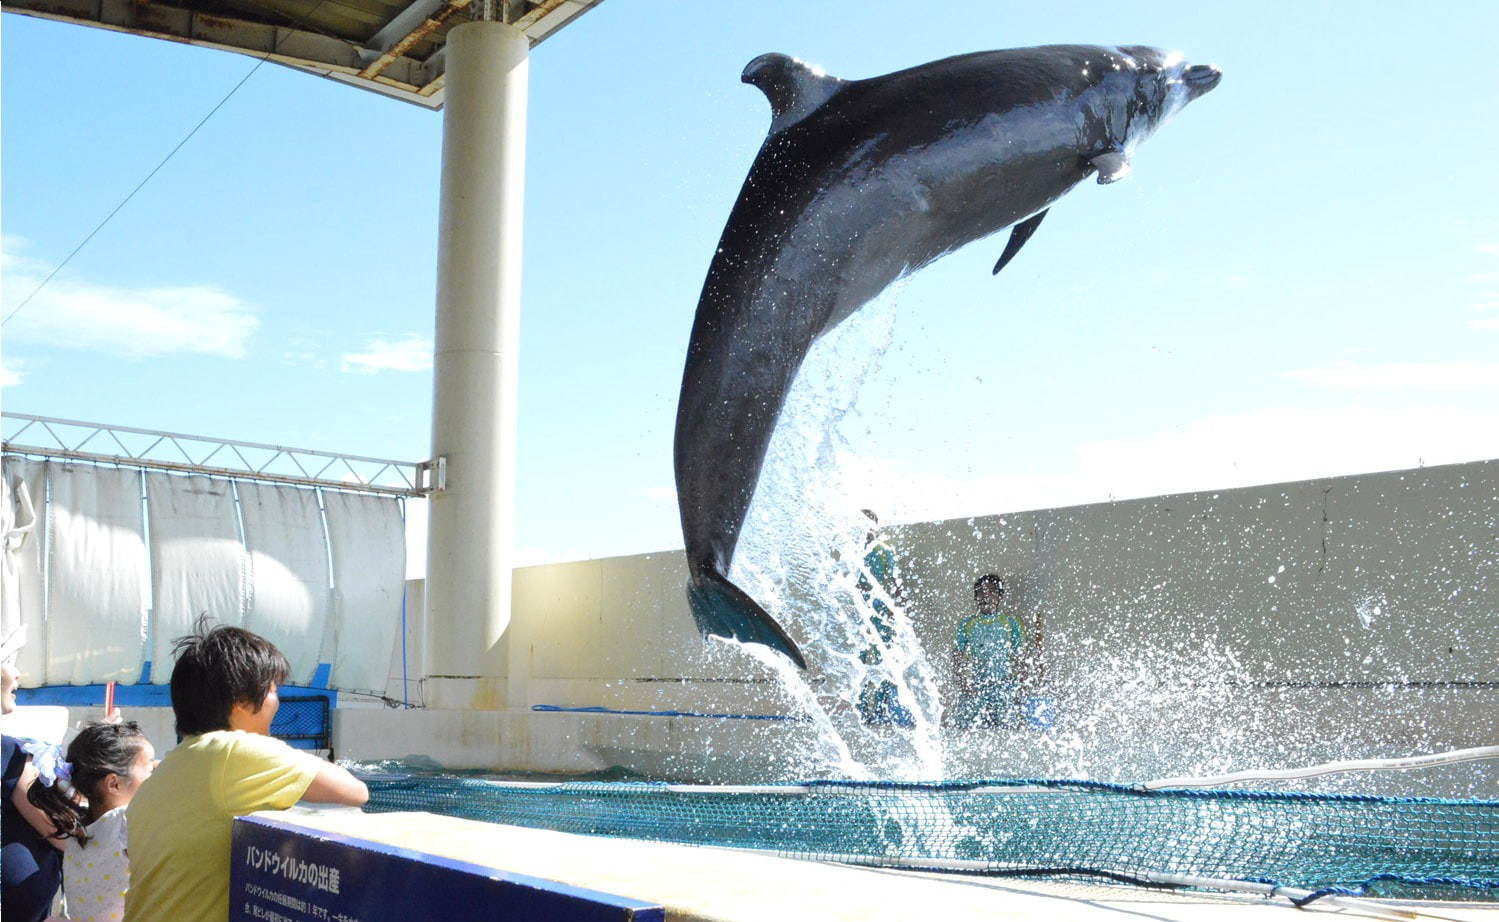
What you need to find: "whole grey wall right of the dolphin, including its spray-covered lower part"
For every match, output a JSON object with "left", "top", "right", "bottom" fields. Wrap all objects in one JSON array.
[{"left": 893, "top": 462, "right": 1499, "bottom": 793}]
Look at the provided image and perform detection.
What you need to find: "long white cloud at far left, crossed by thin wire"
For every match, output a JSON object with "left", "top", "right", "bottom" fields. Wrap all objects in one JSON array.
[{"left": 0, "top": 237, "right": 261, "bottom": 358}]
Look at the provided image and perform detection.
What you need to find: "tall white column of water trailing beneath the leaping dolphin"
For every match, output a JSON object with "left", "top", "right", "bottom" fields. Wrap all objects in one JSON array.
[{"left": 719, "top": 283, "right": 944, "bottom": 780}]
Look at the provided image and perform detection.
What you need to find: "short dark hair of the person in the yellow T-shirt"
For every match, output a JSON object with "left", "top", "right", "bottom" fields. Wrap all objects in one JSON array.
[{"left": 172, "top": 616, "right": 291, "bottom": 738}]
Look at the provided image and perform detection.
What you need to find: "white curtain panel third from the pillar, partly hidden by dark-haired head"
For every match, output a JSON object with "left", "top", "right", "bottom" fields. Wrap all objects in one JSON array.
[{"left": 145, "top": 474, "right": 247, "bottom": 685}]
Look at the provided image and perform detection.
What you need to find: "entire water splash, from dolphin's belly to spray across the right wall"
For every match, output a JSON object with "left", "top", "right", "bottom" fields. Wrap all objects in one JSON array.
[{"left": 689, "top": 286, "right": 1492, "bottom": 791}]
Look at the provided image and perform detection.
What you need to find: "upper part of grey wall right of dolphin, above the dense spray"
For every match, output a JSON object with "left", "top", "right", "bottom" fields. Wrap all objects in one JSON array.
[{"left": 895, "top": 462, "right": 1499, "bottom": 684}]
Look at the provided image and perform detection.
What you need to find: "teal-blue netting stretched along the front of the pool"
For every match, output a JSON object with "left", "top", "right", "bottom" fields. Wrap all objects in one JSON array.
[{"left": 367, "top": 775, "right": 1499, "bottom": 900}]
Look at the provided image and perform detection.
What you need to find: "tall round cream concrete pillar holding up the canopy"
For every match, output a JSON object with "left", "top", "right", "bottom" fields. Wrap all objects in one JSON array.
[{"left": 426, "top": 21, "right": 528, "bottom": 708}]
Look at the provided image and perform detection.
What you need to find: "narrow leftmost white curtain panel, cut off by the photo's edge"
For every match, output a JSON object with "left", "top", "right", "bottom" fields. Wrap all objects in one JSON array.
[{"left": 0, "top": 456, "right": 48, "bottom": 685}]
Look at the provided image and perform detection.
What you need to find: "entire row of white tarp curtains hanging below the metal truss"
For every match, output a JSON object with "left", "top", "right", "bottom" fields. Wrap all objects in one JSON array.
[{"left": 0, "top": 454, "right": 406, "bottom": 694}]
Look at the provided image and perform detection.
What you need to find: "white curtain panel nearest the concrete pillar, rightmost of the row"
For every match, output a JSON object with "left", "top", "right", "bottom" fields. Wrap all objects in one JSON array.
[{"left": 322, "top": 490, "right": 406, "bottom": 694}]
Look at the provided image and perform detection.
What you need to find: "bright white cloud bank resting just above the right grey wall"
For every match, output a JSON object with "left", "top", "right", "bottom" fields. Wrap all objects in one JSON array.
[{"left": 841, "top": 406, "right": 1499, "bottom": 522}]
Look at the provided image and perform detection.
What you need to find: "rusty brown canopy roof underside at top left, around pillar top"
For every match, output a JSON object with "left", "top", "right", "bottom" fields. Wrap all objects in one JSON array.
[{"left": 4, "top": 0, "right": 603, "bottom": 109}]
